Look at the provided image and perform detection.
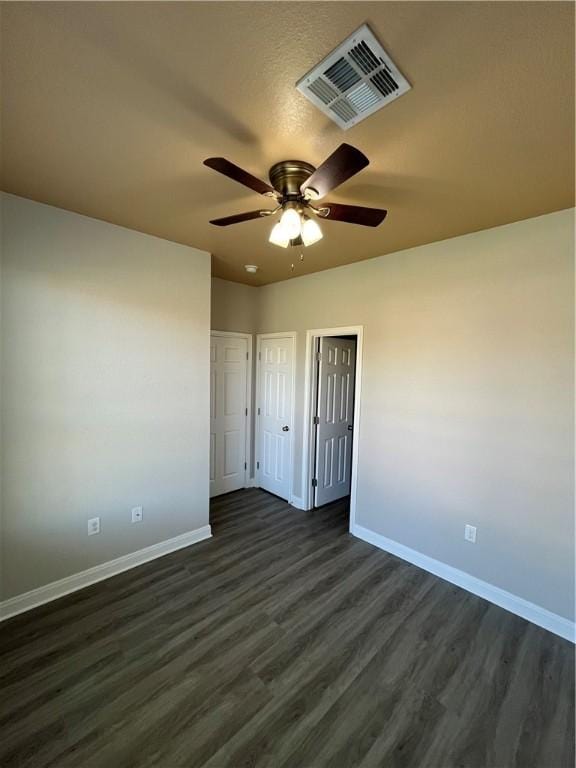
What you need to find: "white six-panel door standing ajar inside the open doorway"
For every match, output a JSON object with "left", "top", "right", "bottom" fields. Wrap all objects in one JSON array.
[{"left": 314, "top": 337, "right": 356, "bottom": 507}]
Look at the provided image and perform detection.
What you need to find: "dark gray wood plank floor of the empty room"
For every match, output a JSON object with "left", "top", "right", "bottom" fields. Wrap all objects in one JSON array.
[{"left": 0, "top": 490, "right": 574, "bottom": 768}]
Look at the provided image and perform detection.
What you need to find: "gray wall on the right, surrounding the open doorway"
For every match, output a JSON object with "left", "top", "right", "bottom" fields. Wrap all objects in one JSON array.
[{"left": 215, "top": 210, "right": 574, "bottom": 618}]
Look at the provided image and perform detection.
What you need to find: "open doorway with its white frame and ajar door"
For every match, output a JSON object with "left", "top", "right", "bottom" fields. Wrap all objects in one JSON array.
[{"left": 302, "top": 326, "right": 362, "bottom": 524}]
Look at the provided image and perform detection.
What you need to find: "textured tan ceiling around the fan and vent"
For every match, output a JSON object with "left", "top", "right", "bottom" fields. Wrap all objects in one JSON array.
[{"left": 2, "top": 2, "right": 574, "bottom": 285}]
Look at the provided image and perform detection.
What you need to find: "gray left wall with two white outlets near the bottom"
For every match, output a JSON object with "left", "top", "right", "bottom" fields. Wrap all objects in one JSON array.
[{"left": 1, "top": 195, "right": 210, "bottom": 598}]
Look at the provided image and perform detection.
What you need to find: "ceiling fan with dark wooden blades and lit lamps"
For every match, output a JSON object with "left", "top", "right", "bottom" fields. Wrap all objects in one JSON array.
[{"left": 204, "top": 144, "right": 387, "bottom": 248}]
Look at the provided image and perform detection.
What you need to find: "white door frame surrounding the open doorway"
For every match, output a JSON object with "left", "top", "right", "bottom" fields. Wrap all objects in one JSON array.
[{"left": 302, "top": 325, "right": 364, "bottom": 530}]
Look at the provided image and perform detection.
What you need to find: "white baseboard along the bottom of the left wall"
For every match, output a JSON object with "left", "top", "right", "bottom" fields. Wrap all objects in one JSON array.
[{"left": 0, "top": 525, "right": 212, "bottom": 621}]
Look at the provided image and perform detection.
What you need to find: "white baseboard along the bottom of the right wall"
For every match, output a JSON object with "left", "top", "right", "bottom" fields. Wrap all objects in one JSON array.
[{"left": 350, "top": 524, "right": 576, "bottom": 643}]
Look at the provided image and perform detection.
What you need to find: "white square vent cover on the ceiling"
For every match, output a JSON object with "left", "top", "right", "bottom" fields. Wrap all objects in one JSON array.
[{"left": 296, "top": 24, "right": 411, "bottom": 130}]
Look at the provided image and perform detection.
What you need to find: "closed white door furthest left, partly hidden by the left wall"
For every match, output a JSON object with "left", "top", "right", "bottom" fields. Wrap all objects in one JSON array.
[{"left": 210, "top": 334, "right": 248, "bottom": 496}]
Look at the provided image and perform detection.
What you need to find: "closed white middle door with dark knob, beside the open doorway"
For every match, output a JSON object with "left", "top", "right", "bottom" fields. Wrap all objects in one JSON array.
[{"left": 256, "top": 337, "right": 294, "bottom": 501}]
